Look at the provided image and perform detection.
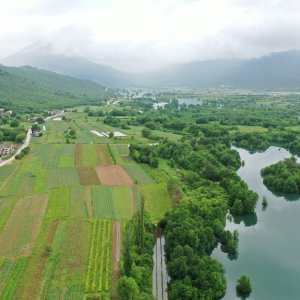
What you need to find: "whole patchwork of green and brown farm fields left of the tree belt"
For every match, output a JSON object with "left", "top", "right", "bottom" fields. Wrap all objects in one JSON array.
[{"left": 0, "top": 108, "right": 168, "bottom": 300}]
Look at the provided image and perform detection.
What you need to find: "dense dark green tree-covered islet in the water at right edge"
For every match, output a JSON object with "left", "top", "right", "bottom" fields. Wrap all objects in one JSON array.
[{"left": 261, "top": 156, "right": 300, "bottom": 194}]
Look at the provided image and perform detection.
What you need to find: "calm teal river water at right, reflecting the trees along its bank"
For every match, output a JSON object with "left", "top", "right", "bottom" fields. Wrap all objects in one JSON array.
[{"left": 213, "top": 147, "right": 300, "bottom": 300}]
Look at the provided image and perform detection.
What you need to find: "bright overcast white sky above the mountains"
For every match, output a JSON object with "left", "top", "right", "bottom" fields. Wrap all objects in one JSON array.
[{"left": 0, "top": 0, "right": 300, "bottom": 72}]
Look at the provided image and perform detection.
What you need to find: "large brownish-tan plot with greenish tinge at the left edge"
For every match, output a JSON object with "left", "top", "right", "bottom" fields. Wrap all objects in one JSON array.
[{"left": 0, "top": 196, "right": 48, "bottom": 257}]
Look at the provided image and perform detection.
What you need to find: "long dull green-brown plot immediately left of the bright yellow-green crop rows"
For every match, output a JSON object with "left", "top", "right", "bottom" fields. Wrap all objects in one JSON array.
[{"left": 47, "top": 220, "right": 92, "bottom": 299}]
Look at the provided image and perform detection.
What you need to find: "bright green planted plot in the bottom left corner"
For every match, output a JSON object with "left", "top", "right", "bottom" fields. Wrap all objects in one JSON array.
[{"left": 0, "top": 257, "right": 27, "bottom": 299}]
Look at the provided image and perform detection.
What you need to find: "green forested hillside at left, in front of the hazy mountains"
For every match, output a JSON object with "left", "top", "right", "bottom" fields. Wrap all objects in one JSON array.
[{"left": 0, "top": 65, "right": 109, "bottom": 112}]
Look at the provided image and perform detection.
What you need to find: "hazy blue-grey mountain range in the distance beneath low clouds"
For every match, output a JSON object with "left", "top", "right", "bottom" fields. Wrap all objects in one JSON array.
[{"left": 2, "top": 47, "right": 300, "bottom": 90}]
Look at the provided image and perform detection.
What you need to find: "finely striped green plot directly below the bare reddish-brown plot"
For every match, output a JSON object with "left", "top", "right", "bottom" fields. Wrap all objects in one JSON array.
[{"left": 92, "top": 186, "right": 116, "bottom": 219}]
